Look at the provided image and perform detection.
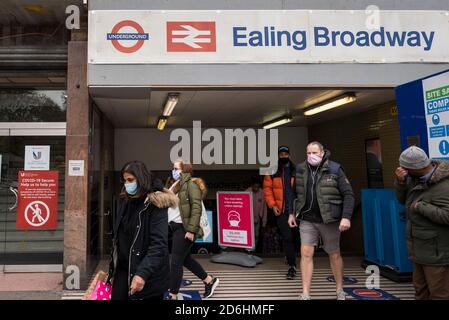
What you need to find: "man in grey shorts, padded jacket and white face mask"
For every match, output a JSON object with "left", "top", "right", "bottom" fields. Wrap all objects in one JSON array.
[{"left": 288, "top": 141, "right": 354, "bottom": 300}]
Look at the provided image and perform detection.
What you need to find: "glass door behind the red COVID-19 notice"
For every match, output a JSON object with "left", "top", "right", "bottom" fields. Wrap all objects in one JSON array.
[{"left": 0, "top": 130, "right": 65, "bottom": 270}]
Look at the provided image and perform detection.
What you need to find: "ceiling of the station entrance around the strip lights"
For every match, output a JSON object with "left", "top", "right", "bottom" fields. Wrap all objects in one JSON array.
[{"left": 90, "top": 88, "right": 395, "bottom": 128}]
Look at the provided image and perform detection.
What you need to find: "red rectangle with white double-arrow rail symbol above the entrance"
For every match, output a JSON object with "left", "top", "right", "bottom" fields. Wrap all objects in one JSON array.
[{"left": 167, "top": 21, "right": 217, "bottom": 52}]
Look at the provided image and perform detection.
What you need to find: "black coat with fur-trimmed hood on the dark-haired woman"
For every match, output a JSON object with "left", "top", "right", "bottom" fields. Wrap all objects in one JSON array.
[{"left": 109, "top": 189, "right": 178, "bottom": 299}]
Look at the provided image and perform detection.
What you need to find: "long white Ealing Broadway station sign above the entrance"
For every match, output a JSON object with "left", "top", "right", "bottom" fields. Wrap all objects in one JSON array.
[{"left": 88, "top": 10, "right": 449, "bottom": 64}]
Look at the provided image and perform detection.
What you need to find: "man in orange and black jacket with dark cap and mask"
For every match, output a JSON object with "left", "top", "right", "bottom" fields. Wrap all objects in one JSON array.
[{"left": 263, "top": 146, "right": 296, "bottom": 280}]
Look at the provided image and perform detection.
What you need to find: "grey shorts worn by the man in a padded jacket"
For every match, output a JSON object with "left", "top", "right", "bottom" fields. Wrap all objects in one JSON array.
[{"left": 299, "top": 220, "right": 340, "bottom": 254}]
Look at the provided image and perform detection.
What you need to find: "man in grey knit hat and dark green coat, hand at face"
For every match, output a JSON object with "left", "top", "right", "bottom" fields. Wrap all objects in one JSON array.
[{"left": 395, "top": 146, "right": 449, "bottom": 300}]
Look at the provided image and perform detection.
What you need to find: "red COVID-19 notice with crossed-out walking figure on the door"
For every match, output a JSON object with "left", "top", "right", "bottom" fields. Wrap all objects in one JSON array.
[{"left": 16, "top": 171, "right": 58, "bottom": 230}]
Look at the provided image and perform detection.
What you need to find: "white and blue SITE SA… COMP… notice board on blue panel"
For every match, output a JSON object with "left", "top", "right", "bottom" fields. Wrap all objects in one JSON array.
[{"left": 423, "top": 72, "right": 449, "bottom": 160}]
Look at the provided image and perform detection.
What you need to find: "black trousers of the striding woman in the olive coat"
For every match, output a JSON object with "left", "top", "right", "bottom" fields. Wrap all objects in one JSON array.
[{"left": 169, "top": 222, "right": 207, "bottom": 294}]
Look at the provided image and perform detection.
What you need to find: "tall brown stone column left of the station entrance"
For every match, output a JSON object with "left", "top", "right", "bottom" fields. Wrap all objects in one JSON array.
[{"left": 64, "top": 41, "right": 91, "bottom": 289}]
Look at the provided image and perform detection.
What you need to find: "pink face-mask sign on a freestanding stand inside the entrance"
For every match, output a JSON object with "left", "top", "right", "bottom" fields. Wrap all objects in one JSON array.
[{"left": 217, "top": 192, "right": 254, "bottom": 249}]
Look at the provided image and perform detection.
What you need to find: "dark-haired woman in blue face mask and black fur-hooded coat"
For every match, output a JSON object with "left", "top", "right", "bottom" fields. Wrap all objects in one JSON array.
[{"left": 109, "top": 161, "right": 177, "bottom": 300}]
